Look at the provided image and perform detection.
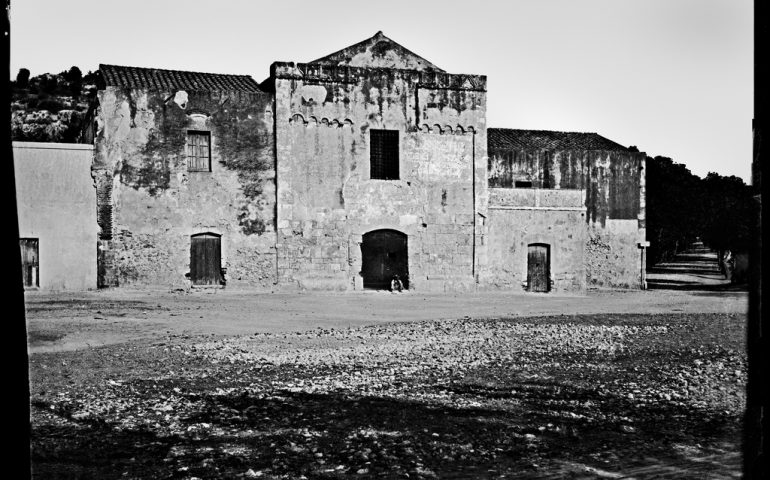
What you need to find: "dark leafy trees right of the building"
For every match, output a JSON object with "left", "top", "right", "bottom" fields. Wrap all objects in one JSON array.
[{"left": 646, "top": 157, "right": 755, "bottom": 262}]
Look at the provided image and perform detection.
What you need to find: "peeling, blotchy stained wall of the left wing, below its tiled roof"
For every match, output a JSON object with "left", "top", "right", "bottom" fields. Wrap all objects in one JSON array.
[{"left": 92, "top": 86, "right": 276, "bottom": 288}]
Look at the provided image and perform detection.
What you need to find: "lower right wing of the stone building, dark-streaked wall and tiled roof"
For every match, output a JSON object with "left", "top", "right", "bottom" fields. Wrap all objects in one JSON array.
[{"left": 487, "top": 128, "right": 646, "bottom": 291}]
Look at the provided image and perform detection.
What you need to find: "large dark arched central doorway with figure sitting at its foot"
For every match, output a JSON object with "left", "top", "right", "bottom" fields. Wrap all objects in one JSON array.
[{"left": 361, "top": 230, "right": 409, "bottom": 289}]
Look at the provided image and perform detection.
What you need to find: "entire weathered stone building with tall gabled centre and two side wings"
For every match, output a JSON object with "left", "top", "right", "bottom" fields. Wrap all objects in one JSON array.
[{"left": 83, "top": 32, "right": 645, "bottom": 292}]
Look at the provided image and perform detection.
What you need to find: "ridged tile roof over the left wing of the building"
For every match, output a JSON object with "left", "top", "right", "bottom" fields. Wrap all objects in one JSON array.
[{"left": 99, "top": 64, "right": 260, "bottom": 92}]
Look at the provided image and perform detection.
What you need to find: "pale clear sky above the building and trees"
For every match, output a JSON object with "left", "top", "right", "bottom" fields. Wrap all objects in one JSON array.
[{"left": 11, "top": 0, "right": 753, "bottom": 183}]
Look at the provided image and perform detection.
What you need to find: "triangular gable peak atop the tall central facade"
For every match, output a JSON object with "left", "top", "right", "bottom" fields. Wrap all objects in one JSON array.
[{"left": 310, "top": 31, "right": 444, "bottom": 72}]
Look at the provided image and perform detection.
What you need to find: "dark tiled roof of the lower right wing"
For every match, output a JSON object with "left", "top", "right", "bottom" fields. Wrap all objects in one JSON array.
[{"left": 487, "top": 128, "right": 628, "bottom": 151}]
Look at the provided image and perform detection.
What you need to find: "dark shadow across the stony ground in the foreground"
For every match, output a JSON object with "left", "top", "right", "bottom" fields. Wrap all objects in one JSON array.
[{"left": 32, "top": 381, "right": 739, "bottom": 479}]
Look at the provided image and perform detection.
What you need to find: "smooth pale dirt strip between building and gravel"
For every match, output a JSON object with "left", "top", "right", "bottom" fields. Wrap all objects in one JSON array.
[{"left": 26, "top": 288, "right": 748, "bottom": 353}]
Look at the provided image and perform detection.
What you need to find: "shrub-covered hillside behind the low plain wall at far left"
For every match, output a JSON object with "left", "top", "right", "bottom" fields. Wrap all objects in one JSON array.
[{"left": 10, "top": 67, "right": 97, "bottom": 143}]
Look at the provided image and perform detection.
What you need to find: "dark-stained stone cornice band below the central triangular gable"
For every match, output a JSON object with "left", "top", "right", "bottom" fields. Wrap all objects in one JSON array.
[{"left": 270, "top": 62, "right": 487, "bottom": 92}]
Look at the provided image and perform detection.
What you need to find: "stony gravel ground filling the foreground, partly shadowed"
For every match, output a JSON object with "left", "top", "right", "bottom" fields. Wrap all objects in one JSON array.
[{"left": 30, "top": 313, "right": 746, "bottom": 479}]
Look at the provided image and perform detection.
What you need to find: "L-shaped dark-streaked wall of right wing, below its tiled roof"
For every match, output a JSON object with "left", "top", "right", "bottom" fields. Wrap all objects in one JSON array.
[{"left": 488, "top": 150, "right": 646, "bottom": 288}]
